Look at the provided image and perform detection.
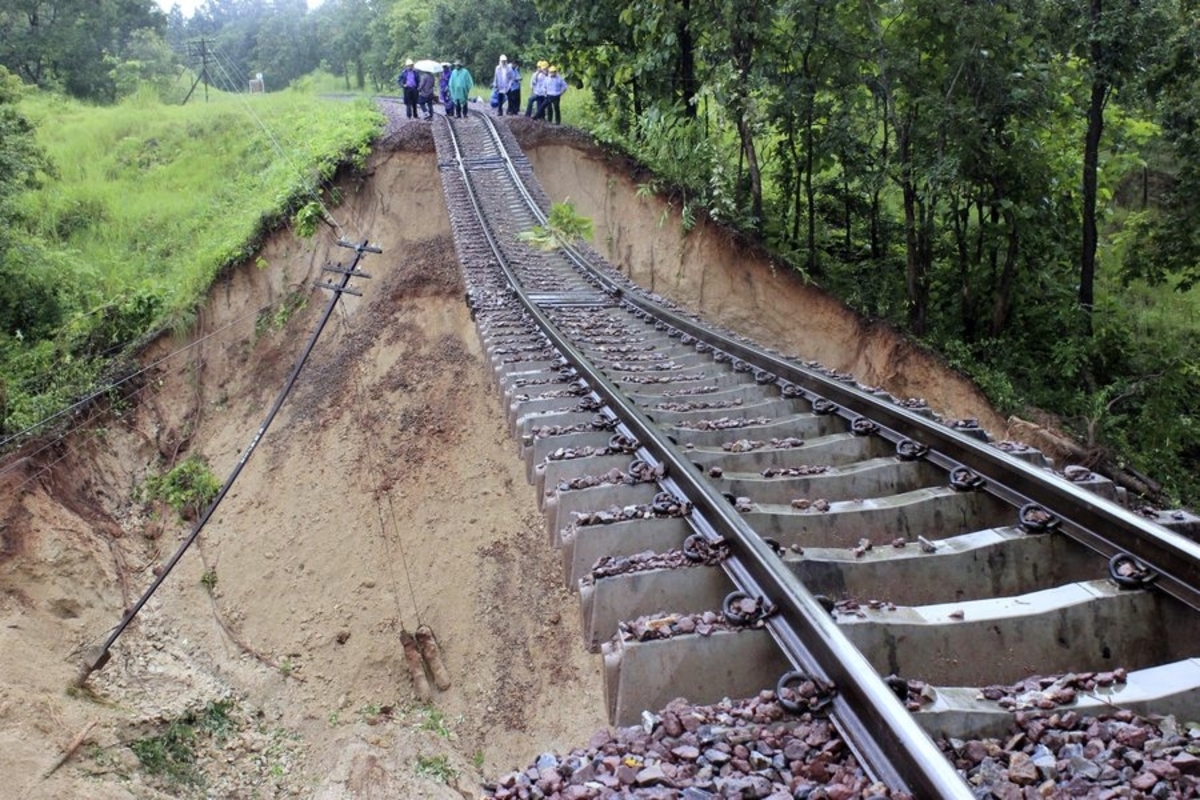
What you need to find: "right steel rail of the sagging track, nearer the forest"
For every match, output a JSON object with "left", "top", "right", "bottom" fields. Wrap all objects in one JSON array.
[{"left": 470, "top": 116, "right": 1200, "bottom": 610}]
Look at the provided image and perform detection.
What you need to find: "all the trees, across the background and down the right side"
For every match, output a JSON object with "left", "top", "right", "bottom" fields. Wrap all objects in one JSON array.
[{"left": 0, "top": 0, "right": 1200, "bottom": 501}]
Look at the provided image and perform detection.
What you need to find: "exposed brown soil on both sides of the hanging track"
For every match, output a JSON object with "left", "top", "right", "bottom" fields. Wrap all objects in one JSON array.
[{"left": 0, "top": 118, "right": 1001, "bottom": 798}]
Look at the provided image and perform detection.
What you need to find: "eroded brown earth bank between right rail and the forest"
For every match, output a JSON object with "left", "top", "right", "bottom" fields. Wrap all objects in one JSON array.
[{"left": 529, "top": 145, "right": 1004, "bottom": 437}]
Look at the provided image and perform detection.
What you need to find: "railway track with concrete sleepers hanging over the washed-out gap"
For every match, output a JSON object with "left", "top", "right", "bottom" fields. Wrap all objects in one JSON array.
[{"left": 434, "top": 114, "right": 1200, "bottom": 798}]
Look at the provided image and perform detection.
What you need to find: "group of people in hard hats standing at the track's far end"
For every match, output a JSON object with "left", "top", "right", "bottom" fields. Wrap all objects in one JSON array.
[{"left": 396, "top": 55, "right": 566, "bottom": 125}]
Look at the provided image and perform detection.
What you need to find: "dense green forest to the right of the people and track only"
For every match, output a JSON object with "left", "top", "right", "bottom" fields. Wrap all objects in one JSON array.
[{"left": 549, "top": 0, "right": 1200, "bottom": 501}]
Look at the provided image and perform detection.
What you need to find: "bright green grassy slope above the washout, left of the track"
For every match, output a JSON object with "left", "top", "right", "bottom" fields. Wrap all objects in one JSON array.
[{"left": 0, "top": 84, "right": 382, "bottom": 438}]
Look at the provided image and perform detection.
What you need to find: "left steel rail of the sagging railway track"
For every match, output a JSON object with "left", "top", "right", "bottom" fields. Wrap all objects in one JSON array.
[{"left": 450, "top": 118, "right": 973, "bottom": 799}]
